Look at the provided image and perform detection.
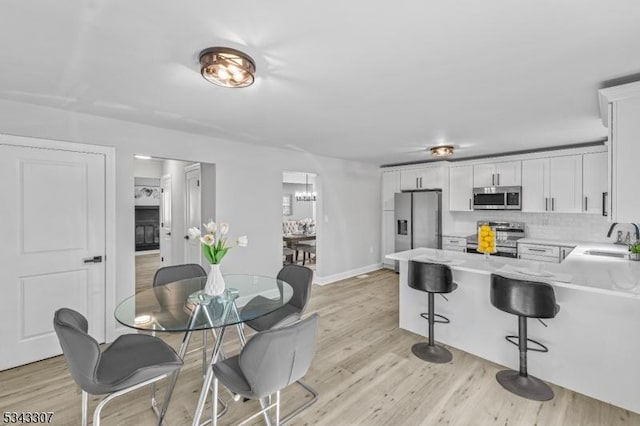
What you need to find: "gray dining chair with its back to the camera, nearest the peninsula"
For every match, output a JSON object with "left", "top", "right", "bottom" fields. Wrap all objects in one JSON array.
[{"left": 212, "top": 314, "right": 318, "bottom": 426}]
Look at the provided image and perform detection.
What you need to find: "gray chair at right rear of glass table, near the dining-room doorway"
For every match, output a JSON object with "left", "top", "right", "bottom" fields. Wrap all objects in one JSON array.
[{"left": 242, "top": 265, "right": 318, "bottom": 423}]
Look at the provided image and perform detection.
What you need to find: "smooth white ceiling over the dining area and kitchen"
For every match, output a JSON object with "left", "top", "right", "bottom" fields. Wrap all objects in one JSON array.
[{"left": 0, "top": 0, "right": 640, "bottom": 164}]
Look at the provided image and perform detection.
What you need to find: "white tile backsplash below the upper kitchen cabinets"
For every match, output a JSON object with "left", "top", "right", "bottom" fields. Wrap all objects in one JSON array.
[{"left": 444, "top": 211, "right": 635, "bottom": 242}]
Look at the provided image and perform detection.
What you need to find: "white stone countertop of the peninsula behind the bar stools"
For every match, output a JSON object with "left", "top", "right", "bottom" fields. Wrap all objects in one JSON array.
[{"left": 387, "top": 243, "right": 640, "bottom": 300}]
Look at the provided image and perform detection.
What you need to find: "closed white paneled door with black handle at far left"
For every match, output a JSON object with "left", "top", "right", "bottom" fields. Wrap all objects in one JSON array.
[{"left": 0, "top": 145, "right": 105, "bottom": 370}]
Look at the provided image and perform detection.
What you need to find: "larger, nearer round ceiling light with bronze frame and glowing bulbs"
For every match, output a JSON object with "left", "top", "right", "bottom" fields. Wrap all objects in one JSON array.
[{"left": 200, "top": 47, "right": 256, "bottom": 88}]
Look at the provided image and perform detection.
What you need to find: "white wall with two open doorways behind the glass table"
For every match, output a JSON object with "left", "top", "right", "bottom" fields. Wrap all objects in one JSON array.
[{"left": 0, "top": 100, "right": 381, "bottom": 336}]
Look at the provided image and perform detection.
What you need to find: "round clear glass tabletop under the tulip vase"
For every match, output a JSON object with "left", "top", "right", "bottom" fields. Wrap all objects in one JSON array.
[{"left": 114, "top": 275, "right": 293, "bottom": 332}]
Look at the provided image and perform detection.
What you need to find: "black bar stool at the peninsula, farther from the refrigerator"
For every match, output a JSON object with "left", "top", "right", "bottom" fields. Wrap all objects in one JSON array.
[{"left": 491, "top": 274, "right": 560, "bottom": 401}]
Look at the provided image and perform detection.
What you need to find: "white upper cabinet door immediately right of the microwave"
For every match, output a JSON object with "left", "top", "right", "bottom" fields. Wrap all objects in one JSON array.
[{"left": 522, "top": 158, "right": 551, "bottom": 212}]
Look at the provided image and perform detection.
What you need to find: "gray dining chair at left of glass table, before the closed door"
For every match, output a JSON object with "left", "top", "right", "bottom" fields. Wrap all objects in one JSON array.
[{"left": 53, "top": 308, "right": 182, "bottom": 426}]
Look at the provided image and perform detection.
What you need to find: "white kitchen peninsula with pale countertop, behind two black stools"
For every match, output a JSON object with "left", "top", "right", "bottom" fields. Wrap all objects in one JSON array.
[{"left": 387, "top": 244, "right": 640, "bottom": 413}]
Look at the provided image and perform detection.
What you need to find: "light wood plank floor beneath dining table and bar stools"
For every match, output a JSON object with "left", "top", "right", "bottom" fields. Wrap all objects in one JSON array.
[{"left": 0, "top": 270, "right": 640, "bottom": 426}]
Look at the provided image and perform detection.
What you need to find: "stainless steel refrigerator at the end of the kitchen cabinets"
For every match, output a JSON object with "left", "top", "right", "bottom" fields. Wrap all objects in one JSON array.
[{"left": 394, "top": 191, "right": 442, "bottom": 270}]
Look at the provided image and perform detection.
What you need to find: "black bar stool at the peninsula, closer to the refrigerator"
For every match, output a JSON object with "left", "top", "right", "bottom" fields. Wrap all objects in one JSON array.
[{"left": 408, "top": 261, "right": 458, "bottom": 363}]
